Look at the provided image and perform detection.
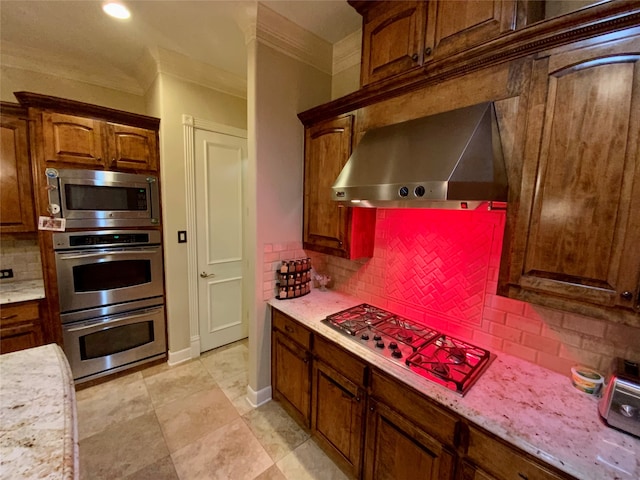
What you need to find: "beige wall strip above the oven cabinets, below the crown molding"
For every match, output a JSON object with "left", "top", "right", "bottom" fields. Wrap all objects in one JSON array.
[{"left": 0, "top": 63, "right": 146, "bottom": 114}]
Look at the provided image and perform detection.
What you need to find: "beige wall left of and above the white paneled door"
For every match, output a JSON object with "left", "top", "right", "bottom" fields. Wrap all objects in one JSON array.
[{"left": 147, "top": 74, "right": 247, "bottom": 353}]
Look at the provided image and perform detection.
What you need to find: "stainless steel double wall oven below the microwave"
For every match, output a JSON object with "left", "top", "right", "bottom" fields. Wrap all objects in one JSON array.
[{"left": 53, "top": 230, "right": 167, "bottom": 383}]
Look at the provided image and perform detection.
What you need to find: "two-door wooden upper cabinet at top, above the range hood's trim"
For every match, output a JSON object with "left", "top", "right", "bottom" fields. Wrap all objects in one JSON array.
[{"left": 349, "top": 0, "right": 542, "bottom": 86}]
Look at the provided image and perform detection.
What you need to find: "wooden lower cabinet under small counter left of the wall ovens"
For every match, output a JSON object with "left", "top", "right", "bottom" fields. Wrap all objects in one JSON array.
[{"left": 0, "top": 301, "right": 44, "bottom": 354}]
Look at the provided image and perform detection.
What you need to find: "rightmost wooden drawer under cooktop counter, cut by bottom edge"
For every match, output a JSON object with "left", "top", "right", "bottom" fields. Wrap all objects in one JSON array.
[{"left": 467, "top": 426, "right": 573, "bottom": 480}]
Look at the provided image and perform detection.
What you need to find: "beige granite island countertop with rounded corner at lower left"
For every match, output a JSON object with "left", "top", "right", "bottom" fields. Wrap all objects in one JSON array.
[{"left": 0, "top": 343, "right": 79, "bottom": 480}]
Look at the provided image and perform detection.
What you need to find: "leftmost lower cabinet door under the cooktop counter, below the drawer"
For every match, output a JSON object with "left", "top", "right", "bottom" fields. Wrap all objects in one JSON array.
[{"left": 272, "top": 332, "right": 311, "bottom": 427}]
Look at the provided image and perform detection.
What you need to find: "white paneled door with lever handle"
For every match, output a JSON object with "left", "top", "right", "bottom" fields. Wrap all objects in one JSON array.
[{"left": 195, "top": 129, "right": 247, "bottom": 352}]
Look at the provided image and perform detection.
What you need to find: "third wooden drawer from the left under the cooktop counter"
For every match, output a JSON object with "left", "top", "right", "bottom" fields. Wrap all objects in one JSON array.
[{"left": 371, "top": 370, "right": 460, "bottom": 446}]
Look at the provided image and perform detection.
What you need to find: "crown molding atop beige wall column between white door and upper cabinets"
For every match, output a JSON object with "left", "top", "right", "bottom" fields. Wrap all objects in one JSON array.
[{"left": 256, "top": 3, "right": 333, "bottom": 75}]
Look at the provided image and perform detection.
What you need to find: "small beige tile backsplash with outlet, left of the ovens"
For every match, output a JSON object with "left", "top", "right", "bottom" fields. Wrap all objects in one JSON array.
[{"left": 0, "top": 237, "right": 42, "bottom": 282}]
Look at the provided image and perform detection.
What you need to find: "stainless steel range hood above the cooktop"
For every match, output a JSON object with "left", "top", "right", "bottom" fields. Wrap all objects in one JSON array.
[{"left": 332, "top": 103, "right": 507, "bottom": 209}]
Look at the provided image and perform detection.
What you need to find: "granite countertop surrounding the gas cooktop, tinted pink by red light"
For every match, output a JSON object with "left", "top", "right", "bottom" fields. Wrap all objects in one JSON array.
[{"left": 269, "top": 290, "right": 640, "bottom": 480}]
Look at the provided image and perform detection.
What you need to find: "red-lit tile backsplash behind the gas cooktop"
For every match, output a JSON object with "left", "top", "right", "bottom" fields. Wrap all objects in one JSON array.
[{"left": 264, "top": 209, "right": 640, "bottom": 376}]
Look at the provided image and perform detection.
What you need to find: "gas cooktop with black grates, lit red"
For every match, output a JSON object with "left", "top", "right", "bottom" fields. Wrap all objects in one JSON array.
[{"left": 323, "top": 303, "right": 491, "bottom": 396}]
